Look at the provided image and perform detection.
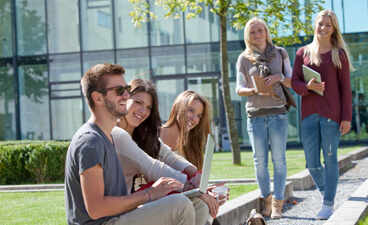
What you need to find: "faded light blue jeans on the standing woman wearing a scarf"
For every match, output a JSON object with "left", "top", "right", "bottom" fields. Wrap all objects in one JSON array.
[{"left": 247, "top": 113, "right": 288, "bottom": 200}]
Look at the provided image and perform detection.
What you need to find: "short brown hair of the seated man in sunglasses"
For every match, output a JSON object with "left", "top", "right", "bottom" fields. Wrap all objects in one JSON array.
[{"left": 81, "top": 63, "right": 125, "bottom": 109}]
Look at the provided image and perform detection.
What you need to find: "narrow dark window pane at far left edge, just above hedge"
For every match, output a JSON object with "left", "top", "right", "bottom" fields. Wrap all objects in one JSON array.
[{"left": 0, "top": 59, "right": 16, "bottom": 140}]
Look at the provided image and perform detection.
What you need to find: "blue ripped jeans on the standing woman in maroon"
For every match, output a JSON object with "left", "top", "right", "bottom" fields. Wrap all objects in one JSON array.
[{"left": 302, "top": 114, "right": 341, "bottom": 206}]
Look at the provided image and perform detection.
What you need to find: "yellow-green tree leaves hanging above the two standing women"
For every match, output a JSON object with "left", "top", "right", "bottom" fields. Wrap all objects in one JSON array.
[{"left": 129, "top": 0, "right": 324, "bottom": 45}]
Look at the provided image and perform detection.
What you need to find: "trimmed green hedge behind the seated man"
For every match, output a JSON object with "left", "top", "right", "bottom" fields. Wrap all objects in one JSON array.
[{"left": 0, "top": 141, "right": 70, "bottom": 184}]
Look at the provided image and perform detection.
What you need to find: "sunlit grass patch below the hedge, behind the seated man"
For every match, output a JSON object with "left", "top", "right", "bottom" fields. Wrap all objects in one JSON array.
[{"left": 0, "top": 191, "right": 66, "bottom": 225}]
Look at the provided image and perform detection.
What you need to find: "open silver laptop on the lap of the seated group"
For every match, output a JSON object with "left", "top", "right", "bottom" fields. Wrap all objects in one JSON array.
[{"left": 181, "top": 134, "right": 215, "bottom": 198}]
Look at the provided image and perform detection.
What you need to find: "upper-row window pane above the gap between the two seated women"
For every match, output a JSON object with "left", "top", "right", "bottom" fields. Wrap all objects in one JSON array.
[{"left": 150, "top": 1, "right": 184, "bottom": 46}]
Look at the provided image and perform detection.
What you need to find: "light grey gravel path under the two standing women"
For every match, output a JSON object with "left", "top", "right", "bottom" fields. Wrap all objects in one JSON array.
[{"left": 266, "top": 157, "right": 368, "bottom": 225}]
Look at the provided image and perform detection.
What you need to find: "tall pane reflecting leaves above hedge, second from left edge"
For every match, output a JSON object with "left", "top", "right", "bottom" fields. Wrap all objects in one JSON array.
[{"left": 18, "top": 61, "right": 50, "bottom": 140}]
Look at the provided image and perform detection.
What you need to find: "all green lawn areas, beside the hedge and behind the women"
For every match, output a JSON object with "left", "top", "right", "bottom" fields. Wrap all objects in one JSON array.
[{"left": 0, "top": 146, "right": 359, "bottom": 225}]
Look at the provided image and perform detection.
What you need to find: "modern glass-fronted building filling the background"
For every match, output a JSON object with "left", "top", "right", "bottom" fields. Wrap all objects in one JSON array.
[{"left": 0, "top": 0, "right": 368, "bottom": 149}]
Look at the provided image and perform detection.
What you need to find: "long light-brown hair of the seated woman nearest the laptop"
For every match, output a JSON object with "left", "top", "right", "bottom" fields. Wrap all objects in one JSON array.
[{"left": 164, "top": 91, "right": 212, "bottom": 170}]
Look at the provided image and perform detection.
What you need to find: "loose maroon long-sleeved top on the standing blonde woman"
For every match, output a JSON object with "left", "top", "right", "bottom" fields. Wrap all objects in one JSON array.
[{"left": 291, "top": 47, "right": 352, "bottom": 124}]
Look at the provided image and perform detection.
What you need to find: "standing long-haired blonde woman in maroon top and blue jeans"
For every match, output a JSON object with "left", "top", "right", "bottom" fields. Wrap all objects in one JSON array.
[{"left": 291, "top": 9, "right": 354, "bottom": 219}]
